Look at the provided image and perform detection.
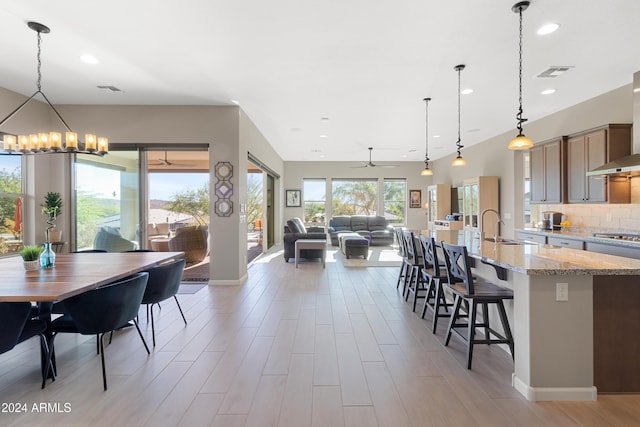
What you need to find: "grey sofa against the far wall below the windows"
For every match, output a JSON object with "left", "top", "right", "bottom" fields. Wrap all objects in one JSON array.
[{"left": 329, "top": 215, "right": 394, "bottom": 246}]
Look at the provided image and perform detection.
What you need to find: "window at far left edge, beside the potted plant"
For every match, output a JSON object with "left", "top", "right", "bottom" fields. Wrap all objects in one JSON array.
[{"left": 0, "top": 155, "right": 23, "bottom": 255}]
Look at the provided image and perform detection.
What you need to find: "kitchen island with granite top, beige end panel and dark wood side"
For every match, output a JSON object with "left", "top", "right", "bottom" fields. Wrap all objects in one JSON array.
[{"left": 422, "top": 230, "right": 640, "bottom": 401}]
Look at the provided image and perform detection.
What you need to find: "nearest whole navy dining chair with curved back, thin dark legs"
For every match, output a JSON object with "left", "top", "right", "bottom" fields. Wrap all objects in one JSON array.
[{"left": 45, "top": 272, "right": 151, "bottom": 390}]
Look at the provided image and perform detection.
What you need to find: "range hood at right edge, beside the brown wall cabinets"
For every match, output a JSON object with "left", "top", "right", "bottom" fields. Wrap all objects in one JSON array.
[{"left": 587, "top": 71, "right": 640, "bottom": 178}]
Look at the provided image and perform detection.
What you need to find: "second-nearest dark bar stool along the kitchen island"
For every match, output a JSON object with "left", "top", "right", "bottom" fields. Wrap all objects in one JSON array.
[{"left": 418, "top": 235, "right": 453, "bottom": 334}]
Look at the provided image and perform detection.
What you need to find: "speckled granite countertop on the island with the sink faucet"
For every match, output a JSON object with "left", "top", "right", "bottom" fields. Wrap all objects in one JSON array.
[{"left": 422, "top": 230, "right": 640, "bottom": 276}]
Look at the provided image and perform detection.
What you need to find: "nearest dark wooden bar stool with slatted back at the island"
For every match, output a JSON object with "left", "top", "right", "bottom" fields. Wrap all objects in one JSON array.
[{"left": 441, "top": 242, "right": 514, "bottom": 369}]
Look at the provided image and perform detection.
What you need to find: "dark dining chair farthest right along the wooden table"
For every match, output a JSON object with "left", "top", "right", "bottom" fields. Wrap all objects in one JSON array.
[{"left": 142, "top": 259, "right": 187, "bottom": 347}]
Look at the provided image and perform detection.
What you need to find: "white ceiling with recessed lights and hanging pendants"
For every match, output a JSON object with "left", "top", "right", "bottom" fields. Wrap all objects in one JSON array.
[{"left": 0, "top": 0, "right": 640, "bottom": 162}]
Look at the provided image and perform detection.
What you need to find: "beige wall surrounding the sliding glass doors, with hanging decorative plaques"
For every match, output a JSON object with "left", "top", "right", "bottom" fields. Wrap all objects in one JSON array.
[{"left": 0, "top": 89, "right": 283, "bottom": 284}]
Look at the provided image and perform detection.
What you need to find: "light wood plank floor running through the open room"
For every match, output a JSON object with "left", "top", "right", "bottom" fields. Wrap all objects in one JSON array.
[{"left": 0, "top": 250, "right": 640, "bottom": 427}]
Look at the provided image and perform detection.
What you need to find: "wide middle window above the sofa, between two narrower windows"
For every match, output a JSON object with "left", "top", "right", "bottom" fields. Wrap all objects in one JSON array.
[{"left": 331, "top": 179, "right": 378, "bottom": 216}]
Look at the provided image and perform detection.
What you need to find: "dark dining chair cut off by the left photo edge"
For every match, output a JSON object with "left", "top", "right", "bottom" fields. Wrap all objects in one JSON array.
[{"left": 0, "top": 302, "right": 55, "bottom": 388}]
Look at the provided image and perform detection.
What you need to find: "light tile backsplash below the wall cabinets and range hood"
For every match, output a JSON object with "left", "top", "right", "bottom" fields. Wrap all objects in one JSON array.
[{"left": 531, "top": 177, "right": 640, "bottom": 233}]
